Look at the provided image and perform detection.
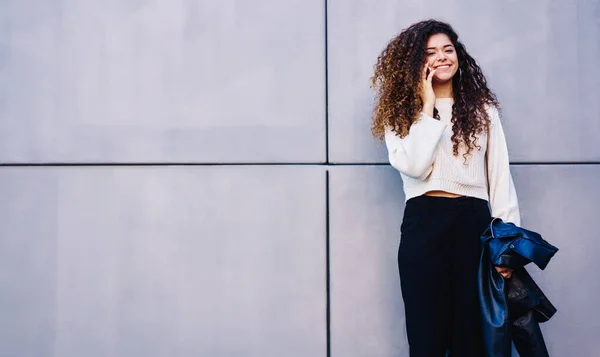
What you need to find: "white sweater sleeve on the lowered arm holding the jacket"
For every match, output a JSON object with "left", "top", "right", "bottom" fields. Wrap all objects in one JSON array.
[{"left": 486, "top": 108, "right": 521, "bottom": 226}]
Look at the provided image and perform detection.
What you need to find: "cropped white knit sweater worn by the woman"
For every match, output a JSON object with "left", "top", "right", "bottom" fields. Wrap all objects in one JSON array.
[{"left": 385, "top": 98, "right": 521, "bottom": 226}]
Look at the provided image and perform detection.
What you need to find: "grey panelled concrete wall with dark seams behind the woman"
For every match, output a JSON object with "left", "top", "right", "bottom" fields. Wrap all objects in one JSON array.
[{"left": 0, "top": 0, "right": 600, "bottom": 357}]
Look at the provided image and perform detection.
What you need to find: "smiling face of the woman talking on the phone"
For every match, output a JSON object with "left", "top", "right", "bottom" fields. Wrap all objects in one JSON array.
[{"left": 426, "top": 33, "right": 458, "bottom": 83}]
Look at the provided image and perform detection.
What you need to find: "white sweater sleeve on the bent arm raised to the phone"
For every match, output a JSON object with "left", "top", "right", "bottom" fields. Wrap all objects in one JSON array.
[{"left": 385, "top": 114, "right": 447, "bottom": 180}]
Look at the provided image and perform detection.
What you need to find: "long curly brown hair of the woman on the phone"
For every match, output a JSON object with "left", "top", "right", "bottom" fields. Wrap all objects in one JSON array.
[{"left": 371, "top": 20, "right": 500, "bottom": 162}]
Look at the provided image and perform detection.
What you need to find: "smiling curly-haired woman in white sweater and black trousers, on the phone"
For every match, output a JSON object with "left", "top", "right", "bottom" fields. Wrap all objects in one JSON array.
[{"left": 371, "top": 20, "right": 520, "bottom": 357}]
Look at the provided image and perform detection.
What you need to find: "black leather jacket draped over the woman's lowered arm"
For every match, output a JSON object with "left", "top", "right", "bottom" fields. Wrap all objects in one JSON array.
[{"left": 478, "top": 218, "right": 558, "bottom": 357}]
